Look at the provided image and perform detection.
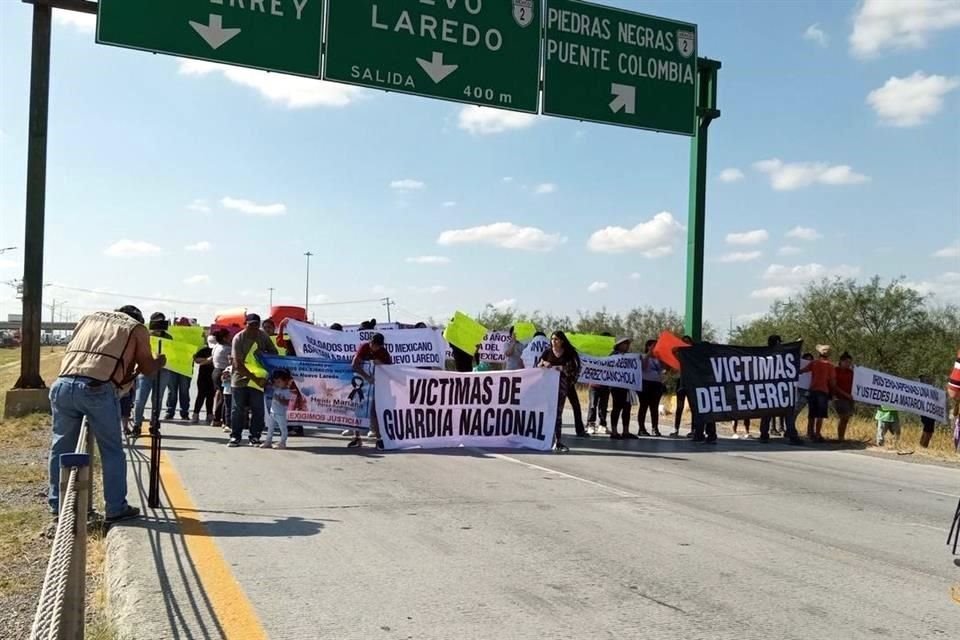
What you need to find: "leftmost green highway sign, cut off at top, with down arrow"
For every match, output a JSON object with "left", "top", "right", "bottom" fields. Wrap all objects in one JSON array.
[{"left": 97, "top": 0, "right": 323, "bottom": 78}]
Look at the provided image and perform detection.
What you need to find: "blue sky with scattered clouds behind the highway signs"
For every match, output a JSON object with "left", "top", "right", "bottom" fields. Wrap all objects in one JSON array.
[{"left": 0, "top": 0, "right": 960, "bottom": 327}]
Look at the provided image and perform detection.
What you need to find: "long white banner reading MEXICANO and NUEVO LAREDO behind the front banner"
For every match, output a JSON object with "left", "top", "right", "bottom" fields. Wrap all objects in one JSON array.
[{"left": 286, "top": 320, "right": 447, "bottom": 369}]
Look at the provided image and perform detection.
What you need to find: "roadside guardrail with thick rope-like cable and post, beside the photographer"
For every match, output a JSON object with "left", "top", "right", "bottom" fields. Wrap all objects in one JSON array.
[{"left": 30, "top": 419, "right": 93, "bottom": 640}]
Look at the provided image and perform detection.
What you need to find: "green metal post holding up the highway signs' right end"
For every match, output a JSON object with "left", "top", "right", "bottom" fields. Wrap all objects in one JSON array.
[{"left": 684, "top": 58, "right": 721, "bottom": 341}]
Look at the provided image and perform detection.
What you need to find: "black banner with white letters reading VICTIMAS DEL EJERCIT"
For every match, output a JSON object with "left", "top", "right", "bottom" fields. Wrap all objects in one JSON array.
[{"left": 676, "top": 342, "right": 802, "bottom": 422}]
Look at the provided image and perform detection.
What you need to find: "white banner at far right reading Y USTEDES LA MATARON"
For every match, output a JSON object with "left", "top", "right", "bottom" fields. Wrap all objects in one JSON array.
[{"left": 853, "top": 367, "right": 947, "bottom": 423}]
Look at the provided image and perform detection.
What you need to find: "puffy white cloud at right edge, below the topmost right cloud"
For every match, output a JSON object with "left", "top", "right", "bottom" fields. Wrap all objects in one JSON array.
[{"left": 867, "top": 71, "right": 960, "bottom": 127}]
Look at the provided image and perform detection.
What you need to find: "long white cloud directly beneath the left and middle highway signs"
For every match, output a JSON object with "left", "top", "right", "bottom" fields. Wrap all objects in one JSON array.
[{"left": 178, "top": 60, "right": 363, "bottom": 109}]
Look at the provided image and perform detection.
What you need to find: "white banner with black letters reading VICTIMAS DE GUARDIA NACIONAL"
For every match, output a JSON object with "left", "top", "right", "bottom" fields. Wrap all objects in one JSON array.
[{"left": 375, "top": 365, "right": 560, "bottom": 451}]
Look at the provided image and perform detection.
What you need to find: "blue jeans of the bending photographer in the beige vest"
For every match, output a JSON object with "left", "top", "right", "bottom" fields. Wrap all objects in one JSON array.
[{"left": 47, "top": 377, "right": 127, "bottom": 518}]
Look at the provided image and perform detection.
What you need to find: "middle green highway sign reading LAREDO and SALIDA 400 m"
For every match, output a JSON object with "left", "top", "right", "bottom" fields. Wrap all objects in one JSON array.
[{"left": 323, "top": 0, "right": 543, "bottom": 113}]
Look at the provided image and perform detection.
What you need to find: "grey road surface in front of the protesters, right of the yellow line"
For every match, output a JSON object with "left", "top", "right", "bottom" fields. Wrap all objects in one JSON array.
[{"left": 144, "top": 425, "right": 960, "bottom": 640}]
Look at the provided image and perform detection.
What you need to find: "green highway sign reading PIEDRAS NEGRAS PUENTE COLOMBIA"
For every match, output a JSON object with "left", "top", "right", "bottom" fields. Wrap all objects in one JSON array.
[{"left": 543, "top": 0, "right": 697, "bottom": 135}]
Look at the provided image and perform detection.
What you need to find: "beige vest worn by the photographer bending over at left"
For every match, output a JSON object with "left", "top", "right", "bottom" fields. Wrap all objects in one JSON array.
[{"left": 60, "top": 311, "right": 140, "bottom": 387}]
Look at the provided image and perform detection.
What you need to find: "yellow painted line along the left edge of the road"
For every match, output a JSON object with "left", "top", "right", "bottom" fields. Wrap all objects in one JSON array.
[{"left": 160, "top": 453, "right": 267, "bottom": 640}]
